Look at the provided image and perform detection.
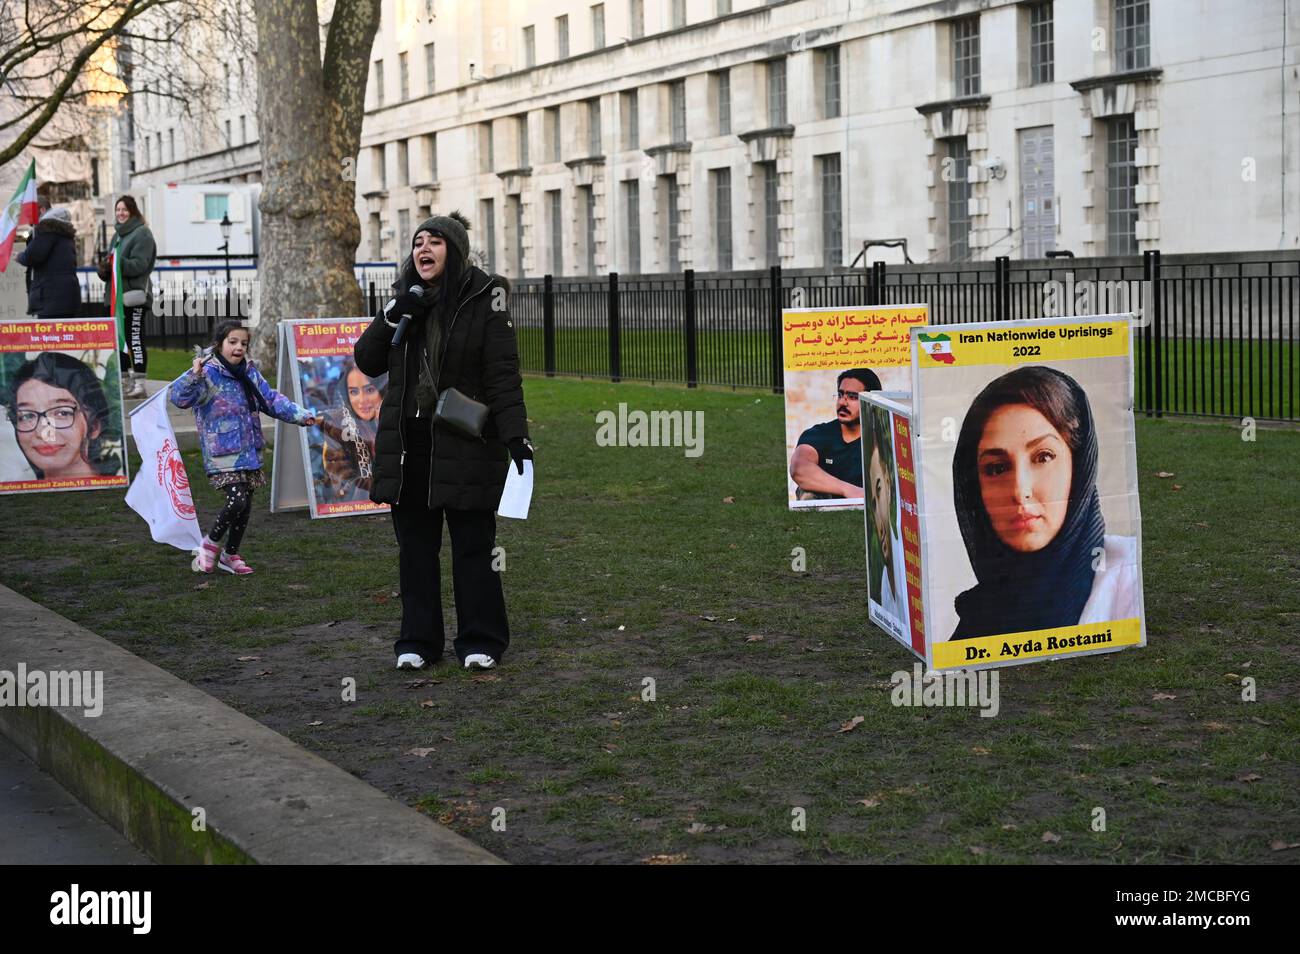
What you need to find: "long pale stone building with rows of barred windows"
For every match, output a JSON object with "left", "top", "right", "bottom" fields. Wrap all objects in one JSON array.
[{"left": 124, "top": 0, "right": 1300, "bottom": 277}]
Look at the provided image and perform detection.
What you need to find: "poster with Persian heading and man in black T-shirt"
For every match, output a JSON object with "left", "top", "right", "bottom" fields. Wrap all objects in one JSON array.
[{"left": 781, "top": 304, "right": 928, "bottom": 509}]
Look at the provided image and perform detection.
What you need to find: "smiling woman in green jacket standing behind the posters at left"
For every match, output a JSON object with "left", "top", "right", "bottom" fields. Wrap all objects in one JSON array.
[{"left": 99, "top": 195, "right": 157, "bottom": 398}]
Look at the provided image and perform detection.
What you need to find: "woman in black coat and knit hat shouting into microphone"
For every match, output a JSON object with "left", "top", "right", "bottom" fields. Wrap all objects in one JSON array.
[{"left": 354, "top": 212, "right": 533, "bottom": 669}]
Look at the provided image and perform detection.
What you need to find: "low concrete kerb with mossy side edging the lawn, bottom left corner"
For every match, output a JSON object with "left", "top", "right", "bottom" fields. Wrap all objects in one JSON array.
[{"left": 0, "top": 586, "right": 501, "bottom": 864}]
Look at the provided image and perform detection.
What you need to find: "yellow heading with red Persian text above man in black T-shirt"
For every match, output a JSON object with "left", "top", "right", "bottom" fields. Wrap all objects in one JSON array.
[{"left": 781, "top": 305, "right": 927, "bottom": 370}]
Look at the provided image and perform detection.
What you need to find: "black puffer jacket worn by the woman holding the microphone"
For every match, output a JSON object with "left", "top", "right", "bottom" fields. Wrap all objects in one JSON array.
[{"left": 354, "top": 268, "right": 528, "bottom": 509}]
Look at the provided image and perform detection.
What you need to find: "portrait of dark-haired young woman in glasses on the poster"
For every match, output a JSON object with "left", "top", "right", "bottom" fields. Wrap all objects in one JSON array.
[{"left": 8, "top": 351, "right": 122, "bottom": 481}]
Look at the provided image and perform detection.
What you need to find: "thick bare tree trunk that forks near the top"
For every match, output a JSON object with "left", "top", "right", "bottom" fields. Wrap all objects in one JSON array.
[{"left": 254, "top": 0, "right": 380, "bottom": 381}]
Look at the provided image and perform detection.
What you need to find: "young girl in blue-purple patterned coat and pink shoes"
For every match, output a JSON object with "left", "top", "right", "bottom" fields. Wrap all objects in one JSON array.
[{"left": 170, "top": 321, "right": 320, "bottom": 576}]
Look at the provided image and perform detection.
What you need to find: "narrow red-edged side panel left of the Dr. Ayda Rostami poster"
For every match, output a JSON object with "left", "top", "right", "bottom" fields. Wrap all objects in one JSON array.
[{"left": 861, "top": 391, "right": 926, "bottom": 659}]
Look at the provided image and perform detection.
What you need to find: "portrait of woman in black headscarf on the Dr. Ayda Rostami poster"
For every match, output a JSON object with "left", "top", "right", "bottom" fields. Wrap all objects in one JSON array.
[{"left": 952, "top": 367, "right": 1141, "bottom": 639}]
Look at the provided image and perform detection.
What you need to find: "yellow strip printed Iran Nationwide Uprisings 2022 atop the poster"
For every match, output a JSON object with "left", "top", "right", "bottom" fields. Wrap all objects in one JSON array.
[{"left": 917, "top": 321, "right": 1128, "bottom": 368}]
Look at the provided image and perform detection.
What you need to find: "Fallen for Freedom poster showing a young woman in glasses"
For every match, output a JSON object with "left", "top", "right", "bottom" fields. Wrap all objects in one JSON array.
[{"left": 0, "top": 317, "right": 127, "bottom": 494}]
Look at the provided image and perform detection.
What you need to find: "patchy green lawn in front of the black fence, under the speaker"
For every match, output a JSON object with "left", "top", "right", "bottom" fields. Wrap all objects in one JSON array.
[{"left": 0, "top": 378, "right": 1300, "bottom": 863}]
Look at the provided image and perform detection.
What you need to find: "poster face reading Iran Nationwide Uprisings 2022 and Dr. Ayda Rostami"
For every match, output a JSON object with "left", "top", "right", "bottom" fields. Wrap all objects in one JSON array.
[{"left": 911, "top": 315, "right": 1147, "bottom": 669}]
